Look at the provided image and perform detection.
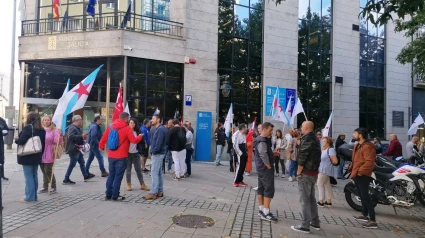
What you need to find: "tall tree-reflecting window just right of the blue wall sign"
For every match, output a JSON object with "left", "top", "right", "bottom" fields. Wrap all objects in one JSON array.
[{"left": 297, "top": 0, "right": 332, "bottom": 129}]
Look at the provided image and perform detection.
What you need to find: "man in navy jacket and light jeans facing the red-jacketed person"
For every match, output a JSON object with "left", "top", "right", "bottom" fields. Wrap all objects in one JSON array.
[{"left": 143, "top": 114, "right": 168, "bottom": 200}]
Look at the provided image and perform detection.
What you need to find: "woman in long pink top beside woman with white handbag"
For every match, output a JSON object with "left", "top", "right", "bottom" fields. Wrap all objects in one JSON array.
[{"left": 38, "top": 116, "right": 59, "bottom": 193}]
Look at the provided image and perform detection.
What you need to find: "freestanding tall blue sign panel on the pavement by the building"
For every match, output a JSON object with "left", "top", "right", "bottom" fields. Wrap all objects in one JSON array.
[{"left": 195, "top": 111, "right": 212, "bottom": 161}]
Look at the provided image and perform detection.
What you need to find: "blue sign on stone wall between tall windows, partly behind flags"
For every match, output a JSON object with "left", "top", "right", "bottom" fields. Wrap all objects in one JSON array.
[{"left": 265, "top": 86, "right": 297, "bottom": 116}]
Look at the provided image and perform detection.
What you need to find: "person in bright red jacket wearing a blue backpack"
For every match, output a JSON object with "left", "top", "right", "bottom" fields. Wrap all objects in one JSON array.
[{"left": 99, "top": 112, "right": 142, "bottom": 201}]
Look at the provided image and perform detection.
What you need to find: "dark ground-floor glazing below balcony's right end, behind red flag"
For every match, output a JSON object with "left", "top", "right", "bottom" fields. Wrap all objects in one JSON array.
[{"left": 127, "top": 57, "right": 184, "bottom": 121}]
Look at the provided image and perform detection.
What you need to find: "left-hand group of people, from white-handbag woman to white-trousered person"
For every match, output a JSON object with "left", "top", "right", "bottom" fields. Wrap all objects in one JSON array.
[{"left": 11, "top": 112, "right": 194, "bottom": 203}]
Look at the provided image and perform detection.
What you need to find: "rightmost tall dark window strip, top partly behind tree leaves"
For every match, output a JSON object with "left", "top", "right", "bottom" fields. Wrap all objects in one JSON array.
[{"left": 359, "top": 0, "right": 385, "bottom": 138}]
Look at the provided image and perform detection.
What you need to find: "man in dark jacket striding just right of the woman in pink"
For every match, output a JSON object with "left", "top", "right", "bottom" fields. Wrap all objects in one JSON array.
[{"left": 63, "top": 115, "right": 94, "bottom": 185}]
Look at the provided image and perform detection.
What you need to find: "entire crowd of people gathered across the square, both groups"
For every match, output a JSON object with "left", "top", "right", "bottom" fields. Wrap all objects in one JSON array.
[{"left": 4, "top": 112, "right": 425, "bottom": 233}]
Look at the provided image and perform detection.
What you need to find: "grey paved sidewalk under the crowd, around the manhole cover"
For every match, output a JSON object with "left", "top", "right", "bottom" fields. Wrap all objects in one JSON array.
[{"left": 2, "top": 148, "right": 425, "bottom": 238}]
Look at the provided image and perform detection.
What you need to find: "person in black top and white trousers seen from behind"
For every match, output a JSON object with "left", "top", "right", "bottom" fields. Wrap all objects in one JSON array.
[{"left": 168, "top": 119, "right": 187, "bottom": 181}]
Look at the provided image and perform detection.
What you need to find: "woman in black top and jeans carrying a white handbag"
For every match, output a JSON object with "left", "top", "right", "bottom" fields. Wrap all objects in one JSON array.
[{"left": 15, "top": 112, "right": 46, "bottom": 203}]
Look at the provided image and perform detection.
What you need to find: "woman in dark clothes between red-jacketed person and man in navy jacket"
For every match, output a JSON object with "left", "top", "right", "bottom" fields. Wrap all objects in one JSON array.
[{"left": 125, "top": 118, "right": 150, "bottom": 191}]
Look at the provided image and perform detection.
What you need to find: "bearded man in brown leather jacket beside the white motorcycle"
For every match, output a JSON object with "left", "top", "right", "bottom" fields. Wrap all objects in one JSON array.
[{"left": 350, "top": 128, "right": 378, "bottom": 229}]
